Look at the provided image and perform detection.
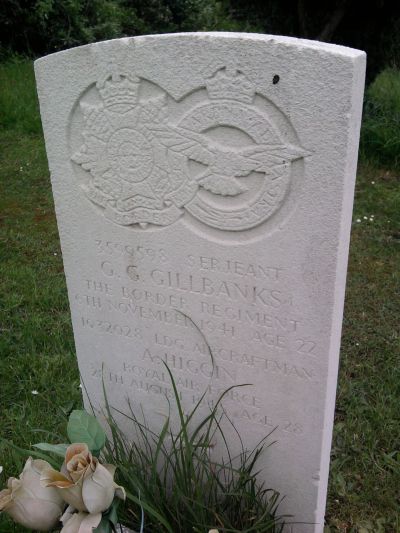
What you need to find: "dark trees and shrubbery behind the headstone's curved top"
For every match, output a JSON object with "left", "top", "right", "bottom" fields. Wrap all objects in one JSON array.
[{"left": 0, "top": 0, "right": 400, "bottom": 79}]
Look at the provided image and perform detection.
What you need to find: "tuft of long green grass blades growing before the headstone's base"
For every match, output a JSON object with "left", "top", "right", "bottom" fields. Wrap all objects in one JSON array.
[{"left": 105, "top": 366, "right": 284, "bottom": 533}]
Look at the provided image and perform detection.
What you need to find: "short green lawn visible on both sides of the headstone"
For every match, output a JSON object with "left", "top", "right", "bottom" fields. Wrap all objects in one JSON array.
[{"left": 0, "top": 62, "right": 400, "bottom": 533}]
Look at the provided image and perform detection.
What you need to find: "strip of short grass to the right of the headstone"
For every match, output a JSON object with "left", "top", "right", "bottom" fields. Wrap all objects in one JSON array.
[{"left": 327, "top": 165, "right": 400, "bottom": 533}]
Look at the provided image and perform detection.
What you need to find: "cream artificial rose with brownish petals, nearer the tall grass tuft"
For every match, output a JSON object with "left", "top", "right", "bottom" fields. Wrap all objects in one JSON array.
[{"left": 41, "top": 444, "right": 125, "bottom": 514}]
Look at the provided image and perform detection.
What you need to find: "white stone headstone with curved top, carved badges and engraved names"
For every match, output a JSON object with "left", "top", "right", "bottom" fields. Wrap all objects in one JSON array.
[{"left": 35, "top": 33, "right": 365, "bottom": 533}]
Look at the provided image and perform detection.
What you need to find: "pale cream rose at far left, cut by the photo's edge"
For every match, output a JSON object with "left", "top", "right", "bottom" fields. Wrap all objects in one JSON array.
[{"left": 0, "top": 457, "right": 65, "bottom": 531}]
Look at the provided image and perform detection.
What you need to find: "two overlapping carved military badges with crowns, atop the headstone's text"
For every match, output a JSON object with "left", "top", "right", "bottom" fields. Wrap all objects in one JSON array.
[{"left": 71, "top": 68, "right": 307, "bottom": 231}]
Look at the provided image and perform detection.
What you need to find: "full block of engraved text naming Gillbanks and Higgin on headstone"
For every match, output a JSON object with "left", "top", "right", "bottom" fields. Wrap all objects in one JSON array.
[{"left": 69, "top": 236, "right": 322, "bottom": 439}]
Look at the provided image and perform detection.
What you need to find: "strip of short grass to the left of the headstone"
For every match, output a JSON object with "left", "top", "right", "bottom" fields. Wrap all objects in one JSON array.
[{"left": 0, "top": 60, "right": 82, "bottom": 533}]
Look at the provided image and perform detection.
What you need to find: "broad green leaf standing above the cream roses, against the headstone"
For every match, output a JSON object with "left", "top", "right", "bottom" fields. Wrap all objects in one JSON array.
[{"left": 67, "top": 410, "right": 106, "bottom": 454}]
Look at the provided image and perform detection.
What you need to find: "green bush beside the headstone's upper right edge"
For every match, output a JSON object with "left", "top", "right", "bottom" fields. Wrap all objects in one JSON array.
[{"left": 361, "top": 69, "right": 400, "bottom": 170}]
